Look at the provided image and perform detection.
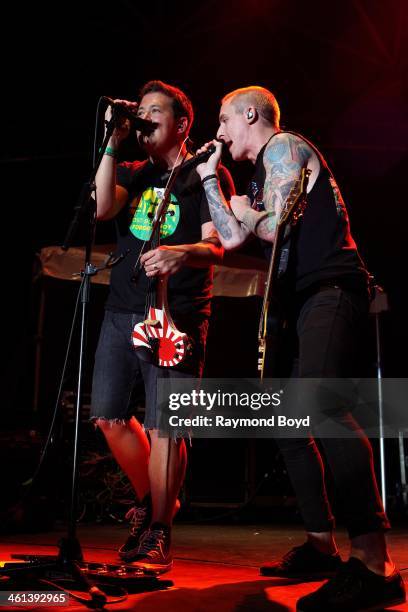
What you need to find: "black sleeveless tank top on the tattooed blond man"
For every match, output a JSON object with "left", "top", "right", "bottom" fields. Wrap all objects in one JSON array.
[{"left": 248, "top": 132, "right": 368, "bottom": 291}]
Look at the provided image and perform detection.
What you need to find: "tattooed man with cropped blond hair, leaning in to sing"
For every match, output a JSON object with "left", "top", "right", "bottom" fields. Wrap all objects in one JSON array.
[{"left": 197, "top": 86, "right": 405, "bottom": 612}]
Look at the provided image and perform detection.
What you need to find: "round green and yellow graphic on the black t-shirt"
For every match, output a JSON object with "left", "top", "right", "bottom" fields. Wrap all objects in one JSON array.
[{"left": 129, "top": 187, "right": 180, "bottom": 240}]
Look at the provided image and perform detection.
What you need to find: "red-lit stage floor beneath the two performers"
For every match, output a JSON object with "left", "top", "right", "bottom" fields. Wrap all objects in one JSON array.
[{"left": 0, "top": 524, "right": 408, "bottom": 612}]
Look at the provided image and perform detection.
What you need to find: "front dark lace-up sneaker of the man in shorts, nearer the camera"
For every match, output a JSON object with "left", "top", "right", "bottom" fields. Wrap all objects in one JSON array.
[{"left": 127, "top": 523, "right": 173, "bottom": 574}]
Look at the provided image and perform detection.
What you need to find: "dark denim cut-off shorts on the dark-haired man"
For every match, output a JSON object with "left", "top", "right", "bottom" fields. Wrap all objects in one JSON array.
[{"left": 90, "top": 310, "right": 208, "bottom": 429}]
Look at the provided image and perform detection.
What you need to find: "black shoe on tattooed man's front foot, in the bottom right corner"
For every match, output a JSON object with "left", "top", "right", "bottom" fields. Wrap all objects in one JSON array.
[{"left": 296, "top": 557, "right": 405, "bottom": 612}]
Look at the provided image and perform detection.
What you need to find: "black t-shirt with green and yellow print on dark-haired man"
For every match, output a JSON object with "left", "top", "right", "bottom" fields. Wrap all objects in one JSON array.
[{"left": 106, "top": 161, "right": 231, "bottom": 318}]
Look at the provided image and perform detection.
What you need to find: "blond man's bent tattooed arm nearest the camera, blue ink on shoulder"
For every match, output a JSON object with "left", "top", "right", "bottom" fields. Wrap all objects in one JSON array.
[{"left": 250, "top": 133, "right": 320, "bottom": 242}]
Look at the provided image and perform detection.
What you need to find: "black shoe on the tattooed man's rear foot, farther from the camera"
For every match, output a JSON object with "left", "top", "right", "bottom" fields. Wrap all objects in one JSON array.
[{"left": 259, "top": 542, "right": 341, "bottom": 578}]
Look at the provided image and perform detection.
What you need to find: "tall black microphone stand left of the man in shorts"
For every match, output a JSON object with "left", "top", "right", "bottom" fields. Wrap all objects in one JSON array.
[{"left": 0, "top": 108, "right": 168, "bottom": 609}]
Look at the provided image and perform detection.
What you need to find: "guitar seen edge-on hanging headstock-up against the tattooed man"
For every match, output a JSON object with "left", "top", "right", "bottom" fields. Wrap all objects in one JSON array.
[{"left": 258, "top": 167, "right": 311, "bottom": 380}]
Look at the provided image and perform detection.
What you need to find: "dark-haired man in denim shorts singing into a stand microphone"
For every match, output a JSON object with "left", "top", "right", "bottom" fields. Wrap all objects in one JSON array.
[{"left": 91, "top": 81, "right": 234, "bottom": 572}]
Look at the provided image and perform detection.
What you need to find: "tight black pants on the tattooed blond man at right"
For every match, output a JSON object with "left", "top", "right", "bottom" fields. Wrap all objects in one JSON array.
[{"left": 277, "top": 287, "right": 390, "bottom": 538}]
